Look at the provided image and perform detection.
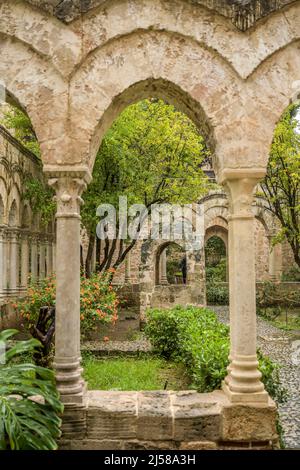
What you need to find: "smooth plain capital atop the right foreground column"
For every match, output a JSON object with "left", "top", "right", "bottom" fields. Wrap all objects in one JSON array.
[{"left": 220, "top": 168, "right": 266, "bottom": 218}]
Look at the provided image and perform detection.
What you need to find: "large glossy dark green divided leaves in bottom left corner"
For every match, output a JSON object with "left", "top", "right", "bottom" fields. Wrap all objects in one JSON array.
[{"left": 0, "top": 330, "right": 63, "bottom": 450}]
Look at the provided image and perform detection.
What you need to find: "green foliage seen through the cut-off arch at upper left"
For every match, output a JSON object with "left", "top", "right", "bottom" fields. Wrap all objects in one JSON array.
[{"left": 1, "top": 105, "right": 41, "bottom": 156}]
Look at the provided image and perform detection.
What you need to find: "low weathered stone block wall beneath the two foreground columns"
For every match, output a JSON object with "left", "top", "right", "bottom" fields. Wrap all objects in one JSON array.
[{"left": 60, "top": 390, "right": 278, "bottom": 450}]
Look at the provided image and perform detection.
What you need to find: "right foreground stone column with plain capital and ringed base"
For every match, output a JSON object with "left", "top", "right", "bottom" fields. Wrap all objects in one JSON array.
[{"left": 221, "top": 169, "right": 269, "bottom": 403}]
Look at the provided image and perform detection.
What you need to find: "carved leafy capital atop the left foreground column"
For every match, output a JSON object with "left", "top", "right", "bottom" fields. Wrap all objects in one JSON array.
[{"left": 45, "top": 167, "right": 91, "bottom": 218}]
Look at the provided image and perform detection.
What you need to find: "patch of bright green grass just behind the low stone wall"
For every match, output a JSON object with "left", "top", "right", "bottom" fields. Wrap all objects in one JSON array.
[{"left": 83, "top": 356, "right": 189, "bottom": 391}]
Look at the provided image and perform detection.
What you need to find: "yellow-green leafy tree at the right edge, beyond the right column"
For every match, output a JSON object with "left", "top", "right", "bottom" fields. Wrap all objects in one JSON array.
[{"left": 261, "top": 104, "right": 300, "bottom": 267}]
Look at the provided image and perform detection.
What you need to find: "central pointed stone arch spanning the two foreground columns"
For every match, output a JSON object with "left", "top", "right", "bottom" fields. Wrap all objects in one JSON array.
[{"left": 71, "top": 32, "right": 241, "bottom": 172}]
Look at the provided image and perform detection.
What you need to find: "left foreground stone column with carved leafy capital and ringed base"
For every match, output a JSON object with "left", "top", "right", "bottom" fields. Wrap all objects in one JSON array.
[{"left": 46, "top": 170, "right": 89, "bottom": 404}]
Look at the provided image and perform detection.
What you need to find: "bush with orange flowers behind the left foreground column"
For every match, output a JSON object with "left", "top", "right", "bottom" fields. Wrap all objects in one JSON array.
[{"left": 12, "top": 272, "right": 119, "bottom": 337}]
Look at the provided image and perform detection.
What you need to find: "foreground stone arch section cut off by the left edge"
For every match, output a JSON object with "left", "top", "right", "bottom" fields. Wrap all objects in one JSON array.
[{"left": 0, "top": 36, "right": 68, "bottom": 162}]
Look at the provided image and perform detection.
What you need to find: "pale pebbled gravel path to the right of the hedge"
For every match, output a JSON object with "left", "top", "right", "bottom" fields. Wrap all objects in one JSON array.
[{"left": 211, "top": 307, "right": 300, "bottom": 449}]
